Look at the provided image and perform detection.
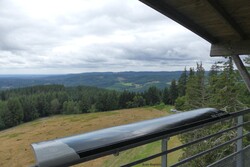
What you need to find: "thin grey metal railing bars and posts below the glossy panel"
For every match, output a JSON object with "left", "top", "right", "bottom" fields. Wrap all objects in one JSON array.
[{"left": 122, "top": 109, "right": 250, "bottom": 167}]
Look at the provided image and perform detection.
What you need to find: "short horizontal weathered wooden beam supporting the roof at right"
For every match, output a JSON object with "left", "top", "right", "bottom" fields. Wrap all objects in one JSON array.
[{"left": 210, "top": 40, "right": 250, "bottom": 57}]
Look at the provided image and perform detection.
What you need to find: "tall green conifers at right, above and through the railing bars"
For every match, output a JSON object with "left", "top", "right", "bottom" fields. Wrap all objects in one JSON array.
[{"left": 179, "top": 58, "right": 249, "bottom": 166}]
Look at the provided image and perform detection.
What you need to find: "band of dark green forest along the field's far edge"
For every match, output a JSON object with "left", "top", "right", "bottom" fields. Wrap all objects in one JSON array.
[{"left": 0, "top": 81, "right": 180, "bottom": 129}]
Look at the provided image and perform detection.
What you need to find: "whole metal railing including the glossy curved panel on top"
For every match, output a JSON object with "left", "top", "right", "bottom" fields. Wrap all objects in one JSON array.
[{"left": 32, "top": 108, "right": 250, "bottom": 167}]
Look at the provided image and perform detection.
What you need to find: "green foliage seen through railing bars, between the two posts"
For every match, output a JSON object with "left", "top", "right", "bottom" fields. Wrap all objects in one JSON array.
[{"left": 180, "top": 122, "right": 235, "bottom": 167}]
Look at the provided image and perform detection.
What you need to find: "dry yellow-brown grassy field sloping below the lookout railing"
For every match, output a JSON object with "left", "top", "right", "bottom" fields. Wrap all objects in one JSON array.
[{"left": 0, "top": 105, "right": 181, "bottom": 167}]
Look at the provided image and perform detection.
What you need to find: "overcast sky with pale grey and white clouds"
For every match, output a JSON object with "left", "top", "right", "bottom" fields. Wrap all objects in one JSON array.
[{"left": 0, "top": 0, "right": 223, "bottom": 74}]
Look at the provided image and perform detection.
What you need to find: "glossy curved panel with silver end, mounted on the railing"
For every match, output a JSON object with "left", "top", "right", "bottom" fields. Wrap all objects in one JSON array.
[{"left": 32, "top": 108, "right": 227, "bottom": 166}]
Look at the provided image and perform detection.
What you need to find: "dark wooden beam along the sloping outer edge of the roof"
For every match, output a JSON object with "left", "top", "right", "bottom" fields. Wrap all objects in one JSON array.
[{"left": 140, "top": 0, "right": 219, "bottom": 43}]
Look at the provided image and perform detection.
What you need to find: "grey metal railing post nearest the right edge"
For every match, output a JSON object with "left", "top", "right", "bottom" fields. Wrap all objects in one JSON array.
[{"left": 236, "top": 115, "right": 243, "bottom": 167}]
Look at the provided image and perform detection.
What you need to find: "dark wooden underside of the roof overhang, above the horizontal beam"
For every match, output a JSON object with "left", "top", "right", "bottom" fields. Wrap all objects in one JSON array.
[{"left": 140, "top": 0, "right": 250, "bottom": 43}]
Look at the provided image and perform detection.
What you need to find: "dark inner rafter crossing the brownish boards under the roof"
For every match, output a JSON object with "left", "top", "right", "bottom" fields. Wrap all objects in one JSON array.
[{"left": 207, "top": 0, "right": 247, "bottom": 39}]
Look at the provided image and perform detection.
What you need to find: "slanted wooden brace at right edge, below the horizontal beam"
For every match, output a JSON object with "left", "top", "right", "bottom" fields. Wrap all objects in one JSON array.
[{"left": 232, "top": 55, "right": 250, "bottom": 92}]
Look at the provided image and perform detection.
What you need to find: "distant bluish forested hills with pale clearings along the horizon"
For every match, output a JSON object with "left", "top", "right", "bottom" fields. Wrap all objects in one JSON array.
[{"left": 0, "top": 71, "right": 182, "bottom": 92}]
